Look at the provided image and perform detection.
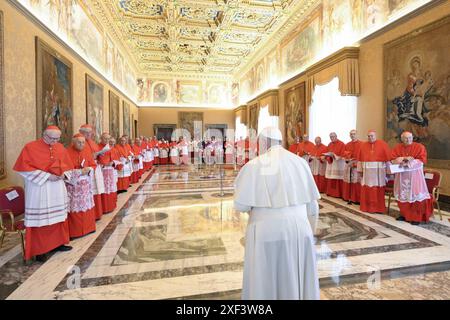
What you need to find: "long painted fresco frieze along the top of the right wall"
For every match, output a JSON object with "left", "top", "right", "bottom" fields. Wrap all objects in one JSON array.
[{"left": 238, "top": 0, "right": 431, "bottom": 103}]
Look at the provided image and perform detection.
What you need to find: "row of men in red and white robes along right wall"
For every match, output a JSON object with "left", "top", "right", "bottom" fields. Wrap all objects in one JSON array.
[{"left": 290, "top": 130, "right": 433, "bottom": 224}]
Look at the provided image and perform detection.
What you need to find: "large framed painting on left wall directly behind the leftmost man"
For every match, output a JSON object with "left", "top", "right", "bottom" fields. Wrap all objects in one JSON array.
[{"left": 36, "top": 37, "right": 73, "bottom": 146}]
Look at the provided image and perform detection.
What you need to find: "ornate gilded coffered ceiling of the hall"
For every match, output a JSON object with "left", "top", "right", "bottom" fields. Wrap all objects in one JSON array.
[{"left": 83, "top": 0, "right": 311, "bottom": 78}]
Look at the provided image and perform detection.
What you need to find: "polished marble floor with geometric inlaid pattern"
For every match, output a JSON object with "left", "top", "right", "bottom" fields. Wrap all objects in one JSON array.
[{"left": 0, "top": 162, "right": 450, "bottom": 300}]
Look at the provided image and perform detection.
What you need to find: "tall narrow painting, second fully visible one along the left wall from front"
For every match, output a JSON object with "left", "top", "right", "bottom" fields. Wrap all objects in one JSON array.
[{"left": 86, "top": 74, "right": 103, "bottom": 141}]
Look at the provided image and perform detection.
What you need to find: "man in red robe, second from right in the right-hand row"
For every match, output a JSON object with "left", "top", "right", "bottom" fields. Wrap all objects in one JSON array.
[{"left": 357, "top": 130, "right": 391, "bottom": 213}]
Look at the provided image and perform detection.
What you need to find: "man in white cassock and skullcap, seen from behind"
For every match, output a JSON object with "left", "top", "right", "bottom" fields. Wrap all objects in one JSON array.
[{"left": 234, "top": 127, "right": 320, "bottom": 300}]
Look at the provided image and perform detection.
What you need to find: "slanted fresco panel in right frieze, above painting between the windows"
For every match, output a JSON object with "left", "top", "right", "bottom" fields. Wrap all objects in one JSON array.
[{"left": 281, "top": 6, "right": 322, "bottom": 75}]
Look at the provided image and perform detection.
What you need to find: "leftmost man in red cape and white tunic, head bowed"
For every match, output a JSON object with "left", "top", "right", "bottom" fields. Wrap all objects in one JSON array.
[{"left": 13, "top": 126, "right": 73, "bottom": 261}]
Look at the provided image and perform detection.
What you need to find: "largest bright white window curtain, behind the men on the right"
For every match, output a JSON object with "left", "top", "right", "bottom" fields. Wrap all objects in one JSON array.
[{"left": 309, "top": 78, "right": 357, "bottom": 145}]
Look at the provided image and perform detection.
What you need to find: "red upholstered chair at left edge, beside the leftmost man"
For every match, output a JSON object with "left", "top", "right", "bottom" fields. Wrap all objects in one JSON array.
[{"left": 0, "top": 186, "right": 25, "bottom": 257}]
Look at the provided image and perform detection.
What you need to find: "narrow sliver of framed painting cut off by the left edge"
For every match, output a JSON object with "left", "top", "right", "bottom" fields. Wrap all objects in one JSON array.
[{"left": 0, "top": 11, "right": 6, "bottom": 179}]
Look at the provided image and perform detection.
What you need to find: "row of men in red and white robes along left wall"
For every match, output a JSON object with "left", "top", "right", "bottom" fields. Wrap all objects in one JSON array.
[{"left": 14, "top": 125, "right": 153, "bottom": 261}]
